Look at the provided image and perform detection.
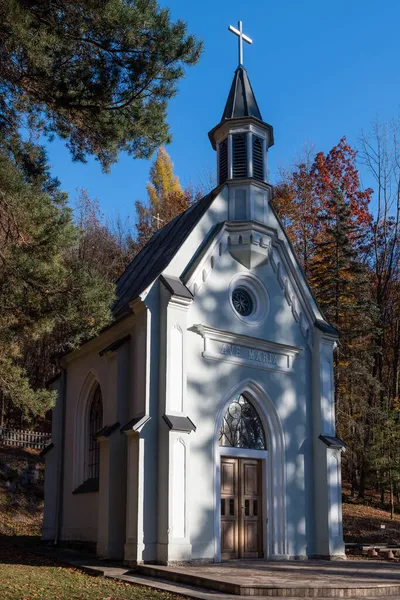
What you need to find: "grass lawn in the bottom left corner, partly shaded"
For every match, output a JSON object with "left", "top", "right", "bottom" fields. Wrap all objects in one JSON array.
[{"left": 0, "top": 536, "right": 178, "bottom": 600}]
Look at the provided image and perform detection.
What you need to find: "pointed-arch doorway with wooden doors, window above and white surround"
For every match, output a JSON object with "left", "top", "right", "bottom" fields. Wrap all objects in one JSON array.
[{"left": 214, "top": 379, "right": 288, "bottom": 561}]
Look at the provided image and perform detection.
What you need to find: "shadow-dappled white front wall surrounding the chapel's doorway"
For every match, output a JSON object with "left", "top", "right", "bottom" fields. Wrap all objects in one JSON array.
[{"left": 152, "top": 187, "right": 340, "bottom": 560}]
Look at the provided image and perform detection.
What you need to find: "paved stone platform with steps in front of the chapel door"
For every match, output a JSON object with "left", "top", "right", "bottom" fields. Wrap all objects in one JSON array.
[{"left": 135, "top": 560, "right": 400, "bottom": 599}]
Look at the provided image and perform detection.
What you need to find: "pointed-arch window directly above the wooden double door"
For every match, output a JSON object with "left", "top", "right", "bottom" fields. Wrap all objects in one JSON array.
[{"left": 219, "top": 394, "right": 267, "bottom": 450}]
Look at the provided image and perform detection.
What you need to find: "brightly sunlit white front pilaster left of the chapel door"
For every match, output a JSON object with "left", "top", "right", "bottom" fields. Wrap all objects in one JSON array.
[{"left": 157, "top": 278, "right": 195, "bottom": 564}]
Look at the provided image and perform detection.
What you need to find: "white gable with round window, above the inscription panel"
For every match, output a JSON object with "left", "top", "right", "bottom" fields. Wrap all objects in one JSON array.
[{"left": 181, "top": 221, "right": 314, "bottom": 346}]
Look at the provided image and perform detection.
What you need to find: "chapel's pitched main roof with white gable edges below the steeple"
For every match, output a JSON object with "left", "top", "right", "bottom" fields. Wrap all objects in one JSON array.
[{"left": 113, "top": 186, "right": 336, "bottom": 343}]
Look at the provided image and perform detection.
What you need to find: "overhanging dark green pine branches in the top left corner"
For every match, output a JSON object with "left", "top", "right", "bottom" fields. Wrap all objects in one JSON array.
[{"left": 0, "top": 0, "right": 202, "bottom": 169}]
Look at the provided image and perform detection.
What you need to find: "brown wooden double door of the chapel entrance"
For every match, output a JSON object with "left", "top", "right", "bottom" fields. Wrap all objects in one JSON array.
[{"left": 221, "top": 457, "right": 263, "bottom": 560}]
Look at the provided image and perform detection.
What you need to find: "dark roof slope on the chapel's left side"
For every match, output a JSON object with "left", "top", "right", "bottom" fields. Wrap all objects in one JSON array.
[{"left": 113, "top": 187, "right": 220, "bottom": 319}]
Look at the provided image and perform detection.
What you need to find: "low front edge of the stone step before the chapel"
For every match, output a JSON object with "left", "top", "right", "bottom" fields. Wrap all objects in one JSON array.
[{"left": 136, "top": 565, "right": 400, "bottom": 599}]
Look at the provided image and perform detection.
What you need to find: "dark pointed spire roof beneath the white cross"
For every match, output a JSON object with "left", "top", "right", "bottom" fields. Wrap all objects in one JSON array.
[{"left": 221, "top": 65, "right": 262, "bottom": 121}]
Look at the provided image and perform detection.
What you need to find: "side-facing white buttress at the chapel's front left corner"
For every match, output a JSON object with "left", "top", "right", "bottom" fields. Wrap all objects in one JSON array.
[{"left": 121, "top": 302, "right": 157, "bottom": 566}]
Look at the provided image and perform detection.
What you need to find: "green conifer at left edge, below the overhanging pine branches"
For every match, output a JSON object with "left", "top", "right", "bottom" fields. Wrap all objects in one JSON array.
[{"left": 0, "top": 144, "right": 114, "bottom": 418}]
